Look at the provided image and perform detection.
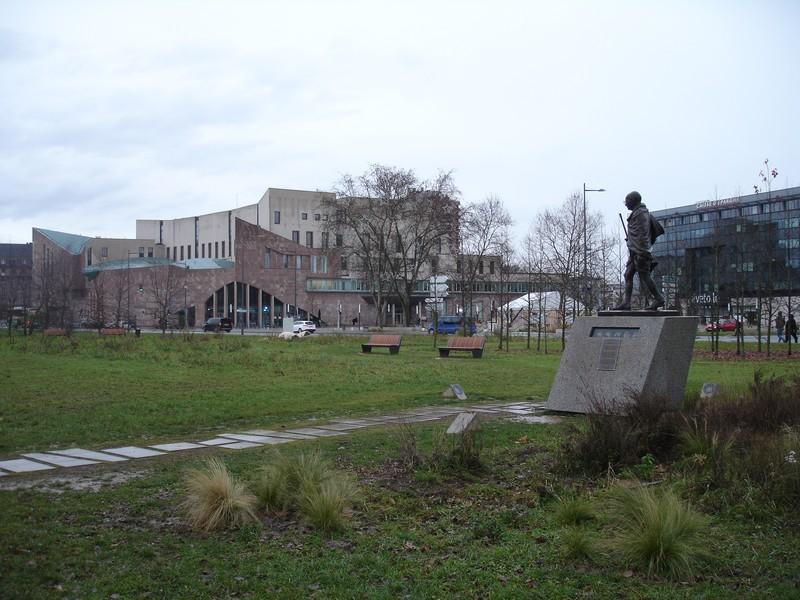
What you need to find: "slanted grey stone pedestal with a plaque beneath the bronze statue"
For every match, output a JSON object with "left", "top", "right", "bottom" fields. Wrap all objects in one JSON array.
[{"left": 547, "top": 312, "right": 698, "bottom": 413}]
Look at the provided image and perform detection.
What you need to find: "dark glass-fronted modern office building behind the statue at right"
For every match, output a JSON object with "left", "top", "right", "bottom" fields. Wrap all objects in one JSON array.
[{"left": 652, "top": 187, "right": 800, "bottom": 321}]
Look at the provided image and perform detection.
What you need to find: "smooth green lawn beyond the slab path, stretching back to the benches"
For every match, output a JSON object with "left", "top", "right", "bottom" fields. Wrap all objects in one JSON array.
[{"left": 0, "top": 334, "right": 794, "bottom": 455}]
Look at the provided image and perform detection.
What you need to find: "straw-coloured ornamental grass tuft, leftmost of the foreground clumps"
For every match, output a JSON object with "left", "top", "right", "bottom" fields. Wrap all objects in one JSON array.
[{"left": 183, "top": 458, "right": 258, "bottom": 531}]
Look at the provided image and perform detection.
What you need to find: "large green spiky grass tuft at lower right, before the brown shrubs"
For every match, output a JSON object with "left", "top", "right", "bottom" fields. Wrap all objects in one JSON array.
[{"left": 610, "top": 487, "right": 706, "bottom": 578}]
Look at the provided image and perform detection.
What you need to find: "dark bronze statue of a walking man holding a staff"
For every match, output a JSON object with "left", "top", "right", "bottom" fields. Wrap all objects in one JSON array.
[{"left": 613, "top": 192, "right": 664, "bottom": 310}]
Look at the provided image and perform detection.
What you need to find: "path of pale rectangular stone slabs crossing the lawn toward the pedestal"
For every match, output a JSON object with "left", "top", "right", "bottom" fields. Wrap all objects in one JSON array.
[{"left": 0, "top": 402, "right": 557, "bottom": 477}]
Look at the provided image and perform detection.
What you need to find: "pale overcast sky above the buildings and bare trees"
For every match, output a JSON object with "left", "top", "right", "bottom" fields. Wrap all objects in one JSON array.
[{"left": 0, "top": 0, "right": 800, "bottom": 242}]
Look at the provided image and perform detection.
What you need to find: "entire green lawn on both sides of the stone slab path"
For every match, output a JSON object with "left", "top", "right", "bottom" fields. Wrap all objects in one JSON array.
[{"left": 0, "top": 335, "right": 800, "bottom": 598}]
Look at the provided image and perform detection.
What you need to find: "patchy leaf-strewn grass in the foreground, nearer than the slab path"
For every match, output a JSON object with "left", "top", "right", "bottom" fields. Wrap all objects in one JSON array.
[{"left": 0, "top": 422, "right": 800, "bottom": 599}]
